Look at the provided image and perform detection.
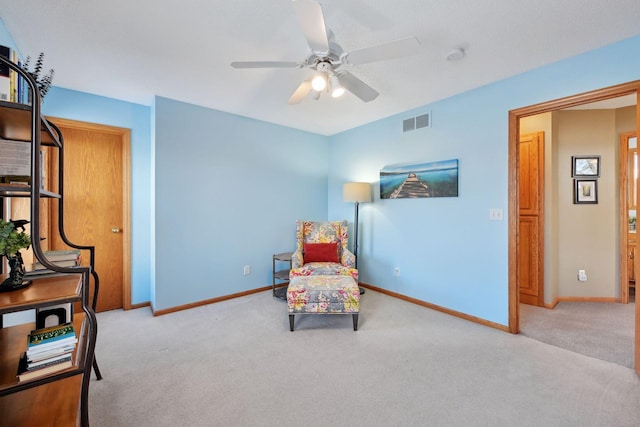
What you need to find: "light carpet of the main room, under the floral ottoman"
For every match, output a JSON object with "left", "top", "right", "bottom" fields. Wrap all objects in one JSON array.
[{"left": 90, "top": 290, "right": 640, "bottom": 427}]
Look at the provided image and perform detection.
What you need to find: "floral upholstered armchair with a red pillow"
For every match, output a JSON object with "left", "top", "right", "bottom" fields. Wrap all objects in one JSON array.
[{"left": 289, "top": 220, "right": 358, "bottom": 283}]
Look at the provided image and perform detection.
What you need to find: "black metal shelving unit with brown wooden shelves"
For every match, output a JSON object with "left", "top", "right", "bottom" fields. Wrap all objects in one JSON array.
[{"left": 0, "top": 57, "right": 102, "bottom": 426}]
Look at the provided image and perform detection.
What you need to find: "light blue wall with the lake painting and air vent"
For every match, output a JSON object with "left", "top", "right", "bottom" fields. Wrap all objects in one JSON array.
[{"left": 328, "top": 37, "right": 640, "bottom": 325}]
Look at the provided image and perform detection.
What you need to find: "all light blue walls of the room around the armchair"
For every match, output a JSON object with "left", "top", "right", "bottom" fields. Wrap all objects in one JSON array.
[{"left": 5, "top": 10, "right": 640, "bottom": 325}]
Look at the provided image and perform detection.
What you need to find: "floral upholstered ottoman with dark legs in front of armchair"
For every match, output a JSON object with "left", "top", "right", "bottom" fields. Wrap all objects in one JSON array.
[{"left": 287, "top": 276, "right": 360, "bottom": 331}]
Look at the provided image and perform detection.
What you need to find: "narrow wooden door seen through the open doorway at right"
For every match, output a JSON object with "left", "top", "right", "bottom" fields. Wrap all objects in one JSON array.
[{"left": 517, "top": 132, "right": 544, "bottom": 307}]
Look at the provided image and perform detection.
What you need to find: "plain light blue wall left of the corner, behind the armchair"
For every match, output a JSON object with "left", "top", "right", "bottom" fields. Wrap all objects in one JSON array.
[{"left": 152, "top": 97, "right": 329, "bottom": 310}]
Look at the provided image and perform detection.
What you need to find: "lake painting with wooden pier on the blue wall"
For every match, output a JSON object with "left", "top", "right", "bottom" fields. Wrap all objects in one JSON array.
[{"left": 380, "top": 159, "right": 458, "bottom": 199}]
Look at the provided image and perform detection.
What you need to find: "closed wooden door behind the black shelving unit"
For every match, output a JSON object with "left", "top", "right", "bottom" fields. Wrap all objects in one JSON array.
[{"left": 49, "top": 119, "right": 130, "bottom": 311}]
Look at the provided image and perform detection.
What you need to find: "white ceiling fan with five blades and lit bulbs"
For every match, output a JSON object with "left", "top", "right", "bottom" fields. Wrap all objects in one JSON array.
[{"left": 231, "top": 0, "right": 420, "bottom": 104}]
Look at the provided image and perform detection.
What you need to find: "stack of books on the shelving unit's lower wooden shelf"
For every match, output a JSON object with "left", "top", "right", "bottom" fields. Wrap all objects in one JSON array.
[{"left": 18, "top": 323, "right": 78, "bottom": 381}]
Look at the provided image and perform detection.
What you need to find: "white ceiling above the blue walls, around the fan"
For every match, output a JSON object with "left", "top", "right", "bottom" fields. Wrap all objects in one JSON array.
[{"left": 0, "top": 0, "right": 640, "bottom": 135}]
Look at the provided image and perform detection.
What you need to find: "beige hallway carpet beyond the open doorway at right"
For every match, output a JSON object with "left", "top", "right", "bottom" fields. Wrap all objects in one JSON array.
[{"left": 520, "top": 302, "right": 640, "bottom": 368}]
